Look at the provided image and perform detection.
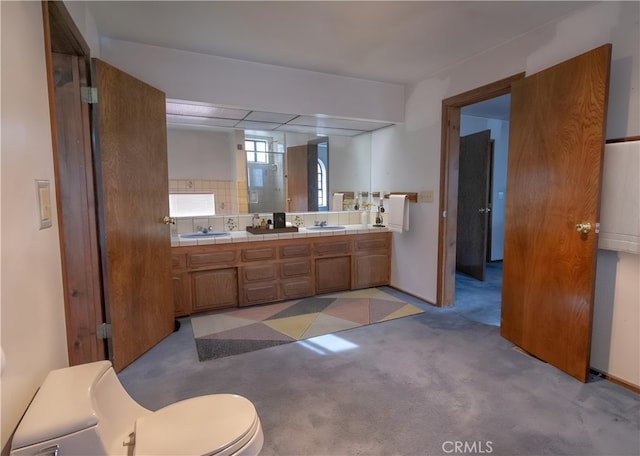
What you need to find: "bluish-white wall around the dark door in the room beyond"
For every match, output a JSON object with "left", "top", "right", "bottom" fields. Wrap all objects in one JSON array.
[{"left": 460, "top": 116, "right": 509, "bottom": 261}]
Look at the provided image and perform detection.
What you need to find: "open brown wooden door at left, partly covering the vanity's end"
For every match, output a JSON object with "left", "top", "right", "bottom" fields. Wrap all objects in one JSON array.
[{"left": 93, "top": 59, "right": 174, "bottom": 371}]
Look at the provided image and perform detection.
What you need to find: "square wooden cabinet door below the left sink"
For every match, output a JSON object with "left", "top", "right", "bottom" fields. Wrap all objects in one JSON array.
[{"left": 191, "top": 268, "right": 238, "bottom": 311}]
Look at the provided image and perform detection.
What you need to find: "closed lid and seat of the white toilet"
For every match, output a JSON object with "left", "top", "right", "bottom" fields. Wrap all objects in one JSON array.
[{"left": 134, "top": 394, "right": 260, "bottom": 456}]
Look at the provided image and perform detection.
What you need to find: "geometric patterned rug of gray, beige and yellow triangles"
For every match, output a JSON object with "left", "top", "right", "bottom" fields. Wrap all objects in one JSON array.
[{"left": 191, "top": 288, "right": 423, "bottom": 361}]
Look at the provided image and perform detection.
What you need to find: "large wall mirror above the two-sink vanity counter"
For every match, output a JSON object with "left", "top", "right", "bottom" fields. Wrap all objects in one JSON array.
[{"left": 167, "top": 123, "right": 371, "bottom": 215}]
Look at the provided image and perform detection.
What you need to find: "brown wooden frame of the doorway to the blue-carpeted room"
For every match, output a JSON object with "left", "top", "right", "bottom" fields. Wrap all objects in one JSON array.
[{"left": 436, "top": 72, "right": 525, "bottom": 307}]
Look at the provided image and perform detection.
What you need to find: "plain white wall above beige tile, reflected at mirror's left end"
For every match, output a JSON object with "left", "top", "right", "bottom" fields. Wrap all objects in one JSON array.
[{"left": 167, "top": 128, "right": 236, "bottom": 181}]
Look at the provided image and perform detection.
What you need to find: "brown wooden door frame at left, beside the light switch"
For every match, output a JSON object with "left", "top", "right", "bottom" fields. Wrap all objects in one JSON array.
[{"left": 42, "top": 1, "right": 107, "bottom": 366}]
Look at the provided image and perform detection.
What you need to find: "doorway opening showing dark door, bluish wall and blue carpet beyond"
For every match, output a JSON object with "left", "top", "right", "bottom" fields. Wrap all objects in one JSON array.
[{"left": 455, "top": 94, "right": 511, "bottom": 326}]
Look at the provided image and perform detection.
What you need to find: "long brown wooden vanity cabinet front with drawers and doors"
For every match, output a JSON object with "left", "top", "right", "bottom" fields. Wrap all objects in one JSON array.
[{"left": 172, "top": 232, "right": 391, "bottom": 316}]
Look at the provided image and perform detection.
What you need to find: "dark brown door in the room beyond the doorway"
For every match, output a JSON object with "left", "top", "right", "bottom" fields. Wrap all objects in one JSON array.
[{"left": 456, "top": 130, "right": 491, "bottom": 280}]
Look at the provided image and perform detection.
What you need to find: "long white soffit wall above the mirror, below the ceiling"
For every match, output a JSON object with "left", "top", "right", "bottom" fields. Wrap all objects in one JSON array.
[{"left": 100, "top": 39, "right": 404, "bottom": 122}]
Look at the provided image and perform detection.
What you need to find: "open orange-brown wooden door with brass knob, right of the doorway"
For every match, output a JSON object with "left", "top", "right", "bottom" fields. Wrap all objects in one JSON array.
[{"left": 501, "top": 45, "right": 611, "bottom": 381}]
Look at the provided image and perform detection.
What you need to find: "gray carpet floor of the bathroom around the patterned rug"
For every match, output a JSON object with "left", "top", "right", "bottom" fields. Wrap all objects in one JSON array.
[{"left": 119, "top": 289, "right": 640, "bottom": 456}]
